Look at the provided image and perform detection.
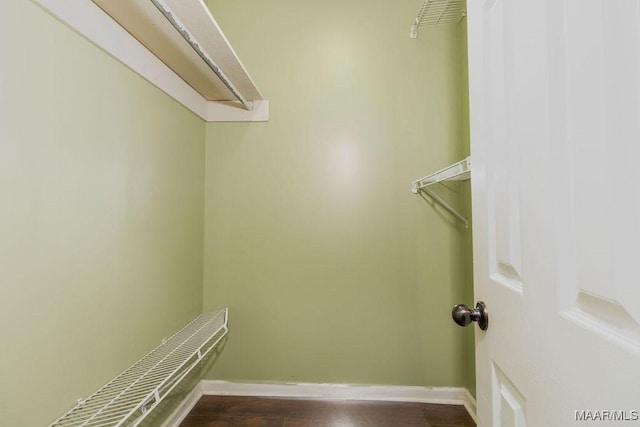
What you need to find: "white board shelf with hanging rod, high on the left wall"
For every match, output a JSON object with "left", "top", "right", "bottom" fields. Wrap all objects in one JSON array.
[{"left": 31, "top": 0, "right": 269, "bottom": 121}]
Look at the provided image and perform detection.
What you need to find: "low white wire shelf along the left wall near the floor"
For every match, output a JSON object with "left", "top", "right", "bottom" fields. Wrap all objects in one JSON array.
[{"left": 51, "top": 309, "right": 229, "bottom": 427}]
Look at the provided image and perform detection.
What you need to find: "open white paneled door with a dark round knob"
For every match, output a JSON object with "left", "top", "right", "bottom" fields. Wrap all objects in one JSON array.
[{"left": 468, "top": 0, "right": 640, "bottom": 427}]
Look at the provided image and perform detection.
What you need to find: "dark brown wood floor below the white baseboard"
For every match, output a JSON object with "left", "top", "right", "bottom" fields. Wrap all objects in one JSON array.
[{"left": 180, "top": 396, "right": 476, "bottom": 427}]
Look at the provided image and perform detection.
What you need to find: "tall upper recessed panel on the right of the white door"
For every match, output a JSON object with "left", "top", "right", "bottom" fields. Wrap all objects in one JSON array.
[{"left": 550, "top": 1, "right": 640, "bottom": 346}]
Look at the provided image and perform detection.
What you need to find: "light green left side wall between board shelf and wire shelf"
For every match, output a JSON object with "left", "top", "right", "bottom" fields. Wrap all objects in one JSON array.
[{"left": 0, "top": 0, "right": 205, "bottom": 427}]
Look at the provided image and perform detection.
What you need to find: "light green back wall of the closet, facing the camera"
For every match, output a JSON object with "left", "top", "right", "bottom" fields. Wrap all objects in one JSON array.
[{"left": 204, "top": 0, "right": 473, "bottom": 386}]
